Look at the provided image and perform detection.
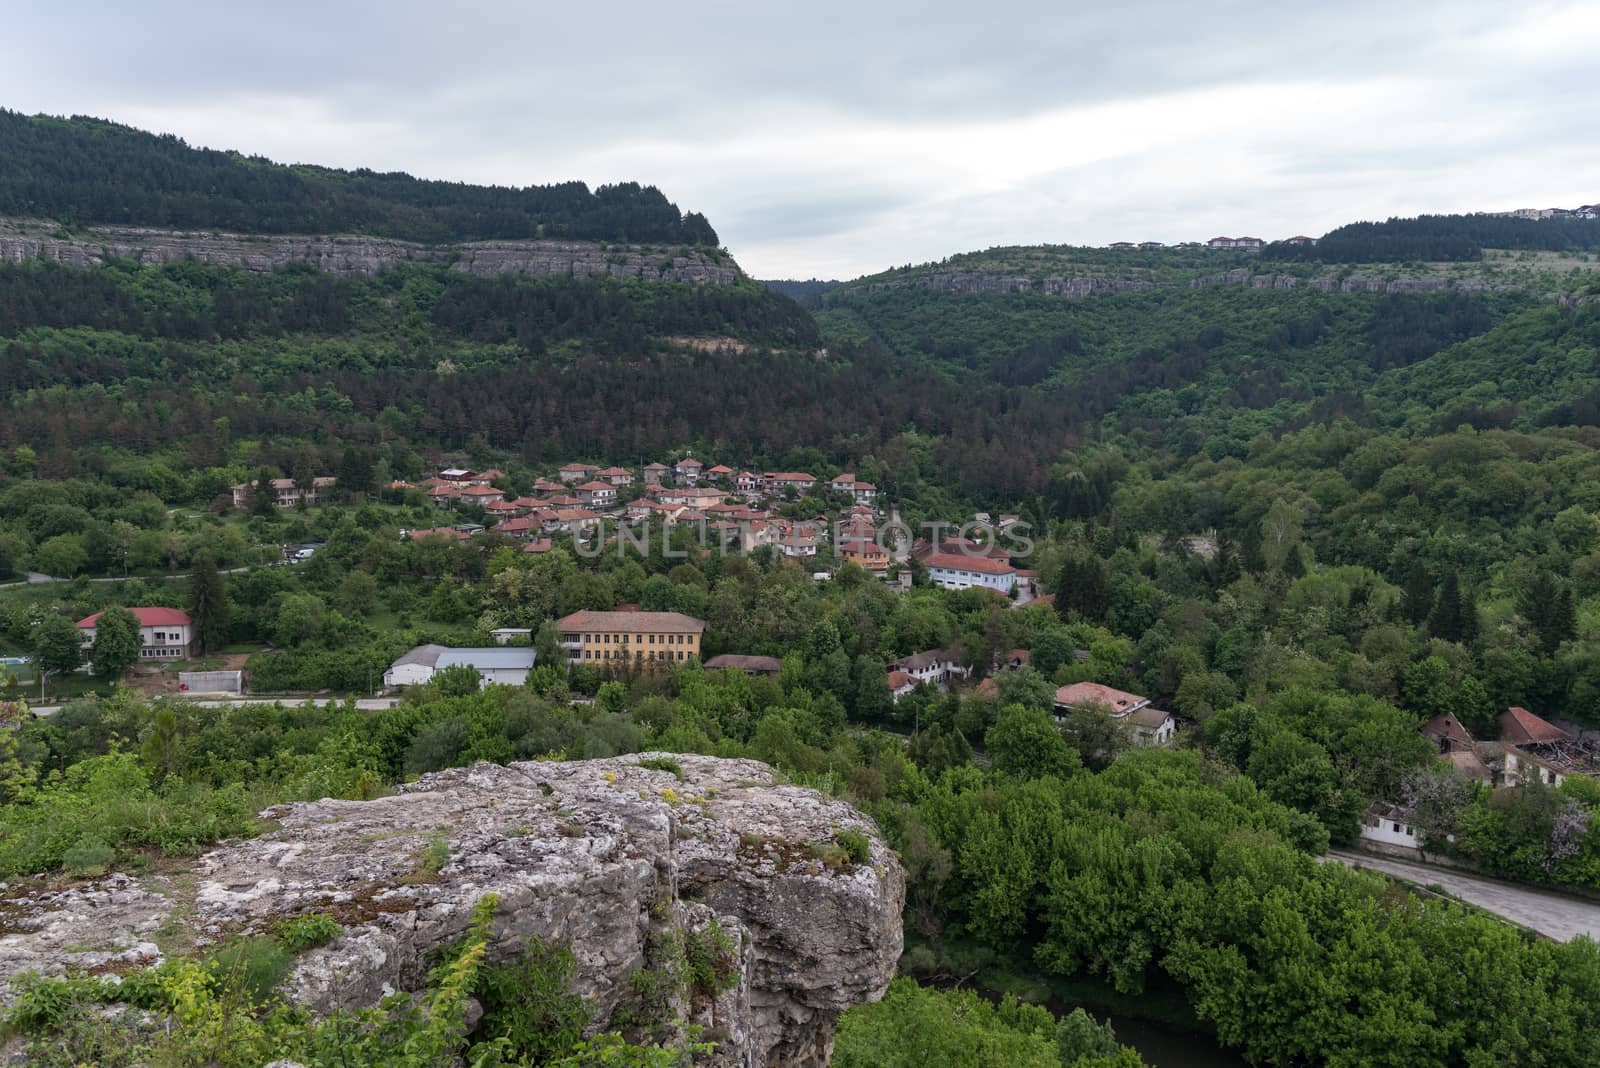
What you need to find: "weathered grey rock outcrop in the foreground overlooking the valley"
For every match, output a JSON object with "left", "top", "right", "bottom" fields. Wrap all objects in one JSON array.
[{"left": 0, "top": 755, "right": 906, "bottom": 1068}]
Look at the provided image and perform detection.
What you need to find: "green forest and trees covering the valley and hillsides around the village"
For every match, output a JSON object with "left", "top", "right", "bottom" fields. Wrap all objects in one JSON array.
[{"left": 0, "top": 158, "right": 1600, "bottom": 1068}]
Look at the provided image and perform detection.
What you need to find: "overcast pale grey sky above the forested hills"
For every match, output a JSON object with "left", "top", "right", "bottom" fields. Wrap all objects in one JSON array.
[{"left": 0, "top": 0, "right": 1600, "bottom": 278}]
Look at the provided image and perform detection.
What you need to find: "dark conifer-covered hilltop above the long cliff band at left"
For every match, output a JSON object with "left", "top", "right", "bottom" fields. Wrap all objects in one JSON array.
[{"left": 0, "top": 109, "right": 717, "bottom": 245}]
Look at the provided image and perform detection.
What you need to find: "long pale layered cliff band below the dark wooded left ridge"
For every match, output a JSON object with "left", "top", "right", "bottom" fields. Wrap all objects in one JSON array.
[{"left": 0, "top": 219, "right": 741, "bottom": 285}]
